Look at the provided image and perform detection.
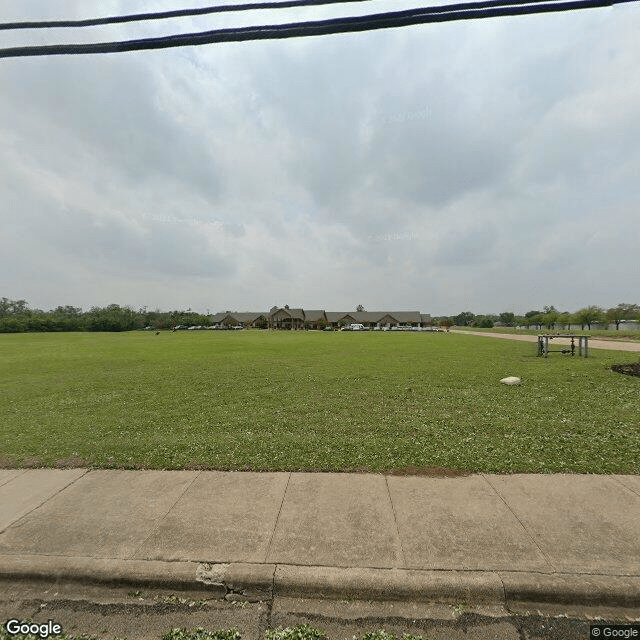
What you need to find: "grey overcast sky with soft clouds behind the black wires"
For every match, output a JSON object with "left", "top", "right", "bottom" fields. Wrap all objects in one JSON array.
[{"left": 0, "top": 0, "right": 640, "bottom": 315}]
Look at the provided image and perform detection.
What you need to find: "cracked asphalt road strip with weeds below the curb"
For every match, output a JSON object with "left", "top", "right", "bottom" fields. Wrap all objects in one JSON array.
[{"left": 0, "top": 581, "right": 640, "bottom": 640}]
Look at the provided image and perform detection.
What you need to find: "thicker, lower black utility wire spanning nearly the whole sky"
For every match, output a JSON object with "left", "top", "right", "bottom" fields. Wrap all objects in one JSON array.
[{"left": 0, "top": 0, "right": 638, "bottom": 58}]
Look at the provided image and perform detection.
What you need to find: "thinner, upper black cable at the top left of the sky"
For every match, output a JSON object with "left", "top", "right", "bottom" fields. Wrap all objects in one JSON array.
[{"left": 0, "top": 0, "right": 371, "bottom": 31}]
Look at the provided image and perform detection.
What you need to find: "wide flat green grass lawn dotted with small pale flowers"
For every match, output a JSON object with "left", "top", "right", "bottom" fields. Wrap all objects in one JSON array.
[{"left": 0, "top": 331, "right": 640, "bottom": 473}]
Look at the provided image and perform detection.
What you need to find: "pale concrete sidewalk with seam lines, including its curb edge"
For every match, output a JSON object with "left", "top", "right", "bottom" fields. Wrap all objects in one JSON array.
[{"left": 0, "top": 469, "right": 640, "bottom": 609}]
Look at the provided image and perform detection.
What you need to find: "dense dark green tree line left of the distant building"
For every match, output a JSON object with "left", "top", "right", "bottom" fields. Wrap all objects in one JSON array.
[{"left": 0, "top": 298, "right": 211, "bottom": 333}]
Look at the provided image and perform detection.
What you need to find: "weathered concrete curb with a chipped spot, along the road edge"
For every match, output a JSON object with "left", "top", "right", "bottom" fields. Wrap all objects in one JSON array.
[{"left": 0, "top": 555, "right": 640, "bottom": 608}]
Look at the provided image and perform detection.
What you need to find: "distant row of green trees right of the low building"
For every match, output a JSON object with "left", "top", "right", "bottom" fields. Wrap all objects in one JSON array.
[{"left": 438, "top": 302, "right": 640, "bottom": 330}]
